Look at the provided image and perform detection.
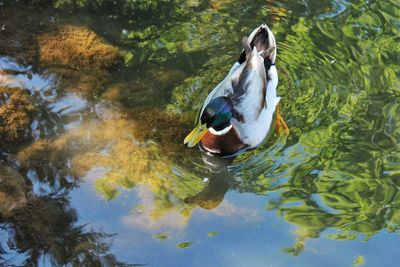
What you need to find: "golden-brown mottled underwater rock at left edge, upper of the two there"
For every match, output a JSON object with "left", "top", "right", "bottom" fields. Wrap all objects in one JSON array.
[{"left": 0, "top": 87, "right": 35, "bottom": 141}]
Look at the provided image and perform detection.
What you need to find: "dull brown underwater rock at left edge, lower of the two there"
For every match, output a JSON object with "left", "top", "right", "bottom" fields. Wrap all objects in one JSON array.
[{"left": 0, "top": 163, "right": 27, "bottom": 217}]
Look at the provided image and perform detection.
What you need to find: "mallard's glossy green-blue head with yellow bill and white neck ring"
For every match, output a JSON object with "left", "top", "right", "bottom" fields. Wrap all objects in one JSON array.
[{"left": 183, "top": 96, "right": 233, "bottom": 147}]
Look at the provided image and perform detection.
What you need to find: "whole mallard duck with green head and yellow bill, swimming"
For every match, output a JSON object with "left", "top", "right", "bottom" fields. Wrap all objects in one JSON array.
[{"left": 184, "top": 24, "right": 286, "bottom": 157}]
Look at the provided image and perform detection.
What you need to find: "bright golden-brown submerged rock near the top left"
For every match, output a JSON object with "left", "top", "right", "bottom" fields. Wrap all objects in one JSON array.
[{"left": 38, "top": 25, "right": 122, "bottom": 69}]
